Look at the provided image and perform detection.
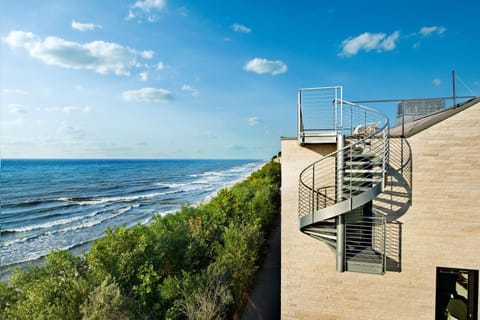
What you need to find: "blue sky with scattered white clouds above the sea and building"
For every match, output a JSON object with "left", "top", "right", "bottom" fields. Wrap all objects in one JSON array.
[{"left": 0, "top": 0, "right": 480, "bottom": 159}]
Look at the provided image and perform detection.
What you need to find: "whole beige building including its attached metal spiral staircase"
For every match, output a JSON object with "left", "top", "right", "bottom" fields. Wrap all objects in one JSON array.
[{"left": 281, "top": 87, "right": 480, "bottom": 319}]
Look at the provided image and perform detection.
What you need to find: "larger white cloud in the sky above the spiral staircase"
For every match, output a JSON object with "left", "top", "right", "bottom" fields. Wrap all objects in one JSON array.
[{"left": 339, "top": 31, "right": 400, "bottom": 57}]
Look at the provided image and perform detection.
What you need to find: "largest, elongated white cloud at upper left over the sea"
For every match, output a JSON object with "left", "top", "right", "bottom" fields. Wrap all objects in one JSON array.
[{"left": 3, "top": 31, "right": 153, "bottom": 76}]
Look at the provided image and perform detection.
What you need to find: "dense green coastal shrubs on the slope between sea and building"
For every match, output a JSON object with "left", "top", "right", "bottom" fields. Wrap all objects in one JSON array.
[{"left": 0, "top": 161, "right": 280, "bottom": 320}]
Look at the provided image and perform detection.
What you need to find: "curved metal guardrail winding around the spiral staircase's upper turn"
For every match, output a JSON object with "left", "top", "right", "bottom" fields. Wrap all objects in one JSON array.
[{"left": 299, "top": 101, "right": 389, "bottom": 218}]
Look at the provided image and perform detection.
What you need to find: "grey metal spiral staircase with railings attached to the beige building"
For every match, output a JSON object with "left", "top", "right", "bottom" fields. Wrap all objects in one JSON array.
[{"left": 298, "top": 87, "right": 389, "bottom": 274}]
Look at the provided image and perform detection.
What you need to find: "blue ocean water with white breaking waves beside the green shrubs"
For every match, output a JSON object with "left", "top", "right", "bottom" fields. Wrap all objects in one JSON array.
[{"left": 0, "top": 160, "right": 263, "bottom": 267}]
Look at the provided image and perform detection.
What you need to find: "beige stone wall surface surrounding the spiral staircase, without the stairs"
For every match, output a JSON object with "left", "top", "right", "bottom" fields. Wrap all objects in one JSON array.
[{"left": 281, "top": 104, "right": 480, "bottom": 320}]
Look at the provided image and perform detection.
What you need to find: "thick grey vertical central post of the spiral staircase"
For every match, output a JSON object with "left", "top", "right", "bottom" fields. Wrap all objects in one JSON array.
[{"left": 335, "top": 134, "right": 345, "bottom": 272}]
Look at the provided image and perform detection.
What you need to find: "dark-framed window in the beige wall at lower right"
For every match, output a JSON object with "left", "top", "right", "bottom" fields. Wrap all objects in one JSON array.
[{"left": 435, "top": 267, "right": 478, "bottom": 320}]
